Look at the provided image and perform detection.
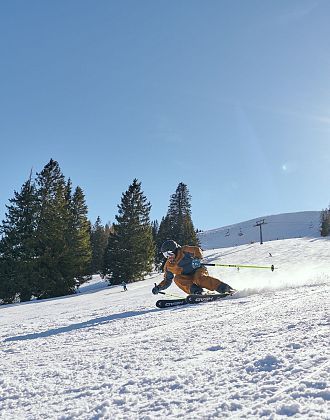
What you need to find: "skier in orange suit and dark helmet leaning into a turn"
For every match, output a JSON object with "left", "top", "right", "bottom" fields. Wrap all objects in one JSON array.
[{"left": 152, "top": 239, "right": 234, "bottom": 295}]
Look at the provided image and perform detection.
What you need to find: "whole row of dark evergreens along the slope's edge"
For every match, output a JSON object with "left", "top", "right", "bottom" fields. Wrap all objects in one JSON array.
[{"left": 0, "top": 159, "right": 198, "bottom": 303}]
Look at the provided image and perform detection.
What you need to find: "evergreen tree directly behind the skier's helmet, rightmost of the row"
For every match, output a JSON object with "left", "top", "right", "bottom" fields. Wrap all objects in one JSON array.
[{"left": 157, "top": 182, "right": 199, "bottom": 245}]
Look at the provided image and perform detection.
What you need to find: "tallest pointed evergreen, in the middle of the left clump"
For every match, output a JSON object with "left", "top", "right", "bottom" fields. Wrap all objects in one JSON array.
[{"left": 34, "top": 159, "right": 76, "bottom": 298}]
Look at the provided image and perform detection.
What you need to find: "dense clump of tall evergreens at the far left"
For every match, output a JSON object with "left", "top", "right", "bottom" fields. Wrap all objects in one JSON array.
[{"left": 0, "top": 159, "right": 91, "bottom": 302}]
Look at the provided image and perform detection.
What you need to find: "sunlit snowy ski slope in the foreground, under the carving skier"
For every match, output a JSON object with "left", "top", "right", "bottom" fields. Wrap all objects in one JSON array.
[{"left": 0, "top": 238, "right": 330, "bottom": 420}]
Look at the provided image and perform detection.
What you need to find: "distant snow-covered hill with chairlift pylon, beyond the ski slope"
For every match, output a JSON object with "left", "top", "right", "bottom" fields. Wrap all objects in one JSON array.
[{"left": 198, "top": 211, "right": 321, "bottom": 249}]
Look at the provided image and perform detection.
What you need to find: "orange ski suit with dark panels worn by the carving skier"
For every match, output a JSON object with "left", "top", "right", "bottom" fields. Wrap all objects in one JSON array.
[{"left": 158, "top": 245, "right": 222, "bottom": 294}]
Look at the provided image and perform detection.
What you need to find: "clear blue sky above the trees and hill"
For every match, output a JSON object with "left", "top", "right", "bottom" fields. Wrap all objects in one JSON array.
[{"left": 0, "top": 0, "right": 330, "bottom": 230}]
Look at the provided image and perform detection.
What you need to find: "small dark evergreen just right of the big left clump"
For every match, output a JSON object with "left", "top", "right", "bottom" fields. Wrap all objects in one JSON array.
[{"left": 91, "top": 217, "right": 109, "bottom": 273}]
